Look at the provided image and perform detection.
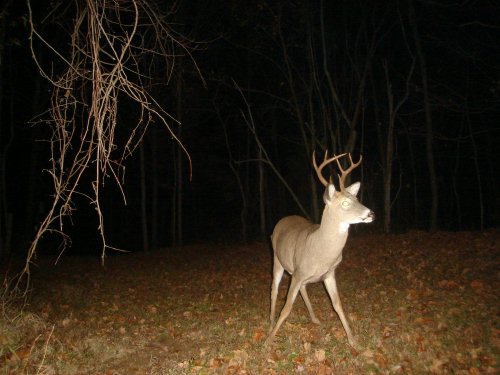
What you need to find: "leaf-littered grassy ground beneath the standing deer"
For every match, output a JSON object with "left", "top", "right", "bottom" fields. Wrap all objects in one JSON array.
[{"left": 0, "top": 231, "right": 500, "bottom": 374}]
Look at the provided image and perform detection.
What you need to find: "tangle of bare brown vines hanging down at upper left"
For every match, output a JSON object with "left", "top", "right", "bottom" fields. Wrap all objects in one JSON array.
[{"left": 18, "top": 0, "right": 196, "bottom": 286}]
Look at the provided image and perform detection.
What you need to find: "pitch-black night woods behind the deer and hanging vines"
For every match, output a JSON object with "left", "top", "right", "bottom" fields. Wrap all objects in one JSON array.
[{"left": 0, "top": 0, "right": 500, "bottom": 255}]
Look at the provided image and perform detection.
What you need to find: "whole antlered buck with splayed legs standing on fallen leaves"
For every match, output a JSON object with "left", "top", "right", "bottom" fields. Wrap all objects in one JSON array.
[{"left": 265, "top": 150, "right": 375, "bottom": 349}]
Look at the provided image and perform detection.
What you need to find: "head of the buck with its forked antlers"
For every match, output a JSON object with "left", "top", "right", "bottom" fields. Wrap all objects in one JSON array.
[{"left": 313, "top": 151, "right": 375, "bottom": 225}]
